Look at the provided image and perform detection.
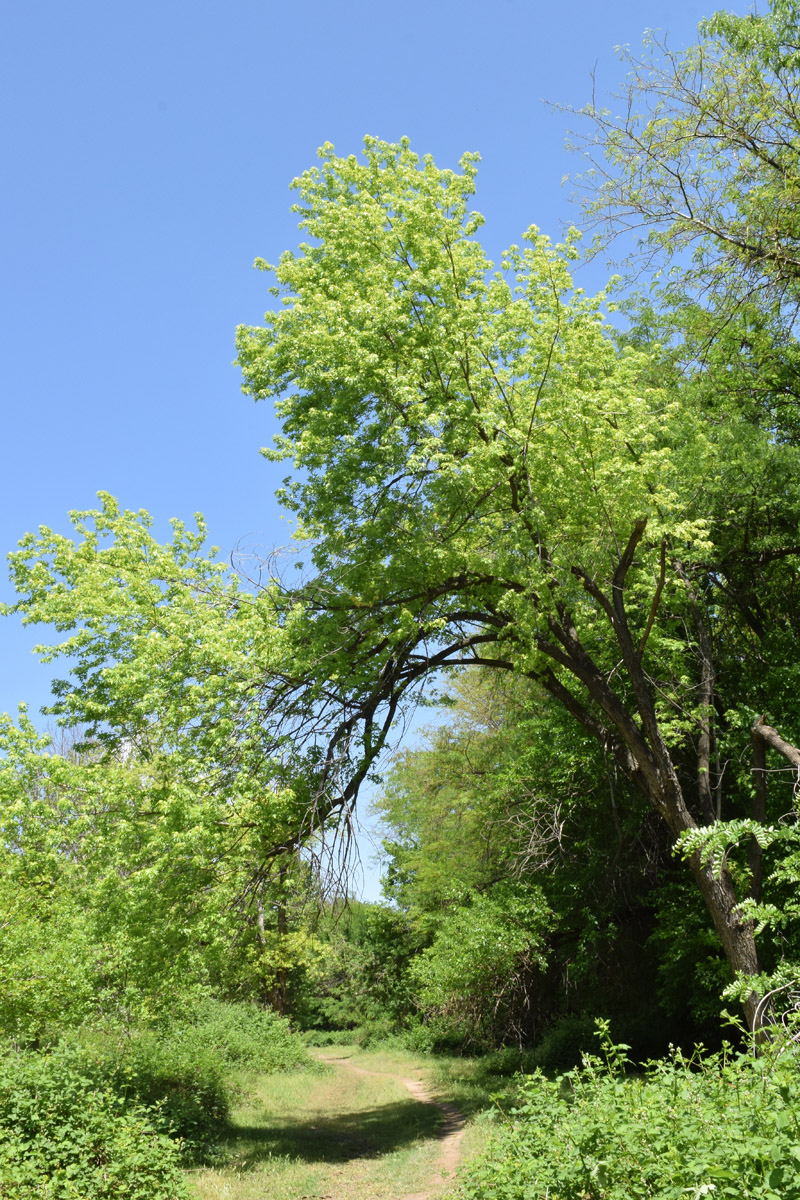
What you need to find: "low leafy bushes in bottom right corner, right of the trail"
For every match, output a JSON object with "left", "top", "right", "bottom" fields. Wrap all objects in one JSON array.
[{"left": 461, "top": 1022, "right": 800, "bottom": 1200}]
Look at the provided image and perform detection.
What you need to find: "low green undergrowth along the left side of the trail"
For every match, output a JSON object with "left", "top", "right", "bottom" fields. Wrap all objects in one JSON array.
[{"left": 0, "top": 1001, "right": 314, "bottom": 1200}]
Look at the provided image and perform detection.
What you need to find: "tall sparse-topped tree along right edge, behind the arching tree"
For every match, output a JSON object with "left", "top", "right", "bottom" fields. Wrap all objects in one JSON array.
[{"left": 579, "top": 0, "right": 800, "bottom": 1003}]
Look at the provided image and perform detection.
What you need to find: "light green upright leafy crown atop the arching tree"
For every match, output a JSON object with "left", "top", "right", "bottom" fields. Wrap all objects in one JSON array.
[{"left": 239, "top": 139, "right": 711, "bottom": 686}]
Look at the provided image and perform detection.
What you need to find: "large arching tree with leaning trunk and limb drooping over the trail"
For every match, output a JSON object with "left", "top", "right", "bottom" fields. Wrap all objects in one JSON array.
[{"left": 7, "top": 138, "right": 798, "bottom": 1021}]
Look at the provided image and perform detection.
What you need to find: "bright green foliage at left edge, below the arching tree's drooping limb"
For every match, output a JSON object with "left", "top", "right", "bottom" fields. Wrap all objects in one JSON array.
[{"left": 0, "top": 712, "right": 319, "bottom": 1042}]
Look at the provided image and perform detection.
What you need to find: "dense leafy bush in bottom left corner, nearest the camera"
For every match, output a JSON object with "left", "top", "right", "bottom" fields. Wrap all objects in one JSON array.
[{"left": 0, "top": 1048, "right": 187, "bottom": 1200}]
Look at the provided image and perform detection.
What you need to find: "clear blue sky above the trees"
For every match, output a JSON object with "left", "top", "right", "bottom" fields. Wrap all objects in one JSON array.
[{"left": 0, "top": 0, "right": 716, "bottom": 897}]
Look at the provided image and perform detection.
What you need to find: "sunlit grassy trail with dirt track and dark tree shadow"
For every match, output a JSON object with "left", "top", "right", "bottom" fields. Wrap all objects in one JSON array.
[{"left": 191, "top": 1046, "right": 476, "bottom": 1200}]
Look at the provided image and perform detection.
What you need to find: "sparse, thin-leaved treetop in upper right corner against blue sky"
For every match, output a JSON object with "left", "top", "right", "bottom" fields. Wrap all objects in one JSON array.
[{"left": 585, "top": 0, "right": 800, "bottom": 311}]
